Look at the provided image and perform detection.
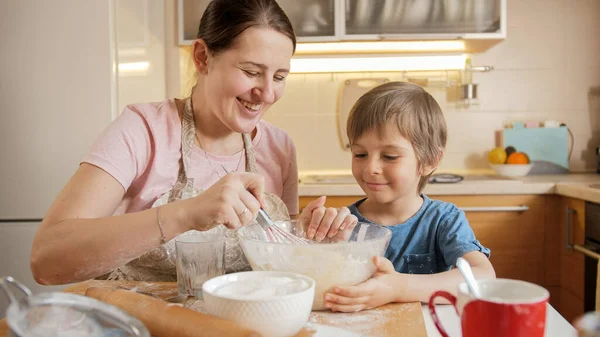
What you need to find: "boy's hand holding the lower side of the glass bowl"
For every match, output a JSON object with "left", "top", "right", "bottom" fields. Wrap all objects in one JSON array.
[{"left": 325, "top": 256, "right": 403, "bottom": 312}]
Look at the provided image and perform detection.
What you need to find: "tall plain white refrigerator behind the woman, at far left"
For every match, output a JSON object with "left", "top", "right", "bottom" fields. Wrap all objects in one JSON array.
[{"left": 0, "top": 0, "right": 116, "bottom": 317}]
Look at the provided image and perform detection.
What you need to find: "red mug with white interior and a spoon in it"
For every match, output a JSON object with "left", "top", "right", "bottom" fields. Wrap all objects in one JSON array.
[{"left": 429, "top": 279, "right": 550, "bottom": 337}]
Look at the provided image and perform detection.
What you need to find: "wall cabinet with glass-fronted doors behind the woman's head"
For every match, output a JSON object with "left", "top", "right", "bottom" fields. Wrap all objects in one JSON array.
[{"left": 178, "top": 0, "right": 507, "bottom": 50}]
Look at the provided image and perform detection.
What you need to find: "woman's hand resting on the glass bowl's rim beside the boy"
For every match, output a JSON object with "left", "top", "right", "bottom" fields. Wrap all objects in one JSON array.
[{"left": 298, "top": 196, "right": 358, "bottom": 242}]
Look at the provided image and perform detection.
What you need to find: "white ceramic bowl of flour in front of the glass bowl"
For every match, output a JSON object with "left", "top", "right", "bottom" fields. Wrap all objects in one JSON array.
[{"left": 202, "top": 271, "right": 315, "bottom": 337}]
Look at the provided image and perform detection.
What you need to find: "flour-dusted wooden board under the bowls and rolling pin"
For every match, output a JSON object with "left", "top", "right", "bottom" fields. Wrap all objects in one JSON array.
[{"left": 0, "top": 280, "right": 427, "bottom": 337}]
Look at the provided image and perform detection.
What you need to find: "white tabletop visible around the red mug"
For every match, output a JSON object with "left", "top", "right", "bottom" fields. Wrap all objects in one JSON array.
[{"left": 421, "top": 304, "right": 577, "bottom": 337}]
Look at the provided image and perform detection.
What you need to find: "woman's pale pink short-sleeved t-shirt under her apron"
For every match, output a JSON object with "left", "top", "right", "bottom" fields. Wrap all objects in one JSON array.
[{"left": 82, "top": 100, "right": 298, "bottom": 214}]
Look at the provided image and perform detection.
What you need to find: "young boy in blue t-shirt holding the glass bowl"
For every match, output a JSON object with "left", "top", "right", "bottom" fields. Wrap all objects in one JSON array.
[{"left": 325, "top": 82, "right": 495, "bottom": 312}]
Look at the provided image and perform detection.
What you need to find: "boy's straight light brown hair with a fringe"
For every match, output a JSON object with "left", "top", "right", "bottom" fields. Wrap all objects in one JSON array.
[{"left": 346, "top": 82, "right": 447, "bottom": 193}]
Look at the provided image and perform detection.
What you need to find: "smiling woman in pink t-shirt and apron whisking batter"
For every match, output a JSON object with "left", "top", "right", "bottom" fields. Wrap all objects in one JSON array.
[{"left": 31, "top": 0, "right": 356, "bottom": 284}]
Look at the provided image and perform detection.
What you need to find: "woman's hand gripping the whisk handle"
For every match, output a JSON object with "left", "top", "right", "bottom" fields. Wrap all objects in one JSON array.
[{"left": 182, "top": 172, "right": 265, "bottom": 231}]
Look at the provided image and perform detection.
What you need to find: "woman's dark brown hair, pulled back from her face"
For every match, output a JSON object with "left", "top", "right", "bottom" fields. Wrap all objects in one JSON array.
[{"left": 196, "top": 0, "right": 296, "bottom": 54}]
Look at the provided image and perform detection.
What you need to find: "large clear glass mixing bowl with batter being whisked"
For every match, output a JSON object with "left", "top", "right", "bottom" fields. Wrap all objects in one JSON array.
[{"left": 238, "top": 220, "right": 392, "bottom": 310}]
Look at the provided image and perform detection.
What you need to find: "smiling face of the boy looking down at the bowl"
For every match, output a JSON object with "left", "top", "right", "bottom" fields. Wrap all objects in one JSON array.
[{"left": 351, "top": 128, "right": 421, "bottom": 204}]
